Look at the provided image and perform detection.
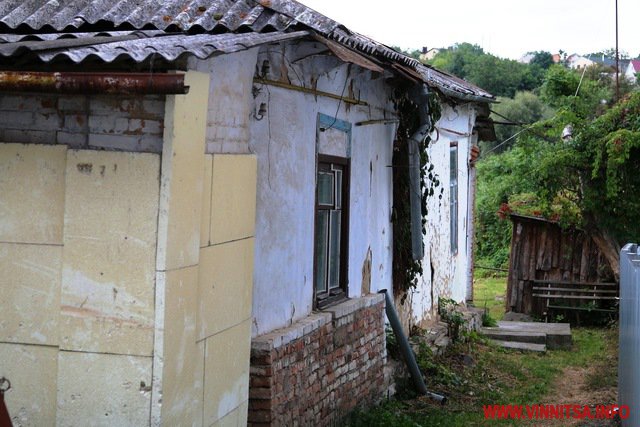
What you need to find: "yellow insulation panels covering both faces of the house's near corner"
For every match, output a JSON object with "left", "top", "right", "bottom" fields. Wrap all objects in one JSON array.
[{"left": 0, "top": 72, "right": 257, "bottom": 426}]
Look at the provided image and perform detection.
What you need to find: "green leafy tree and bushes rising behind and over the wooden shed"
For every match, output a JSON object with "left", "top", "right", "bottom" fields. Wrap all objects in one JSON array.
[{"left": 476, "top": 67, "right": 640, "bottom": 270}]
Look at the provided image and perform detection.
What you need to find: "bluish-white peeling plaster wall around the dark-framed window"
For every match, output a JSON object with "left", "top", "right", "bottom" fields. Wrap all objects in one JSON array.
[{"left": 247, "top": 43, "right": 395, "bottom": 336}]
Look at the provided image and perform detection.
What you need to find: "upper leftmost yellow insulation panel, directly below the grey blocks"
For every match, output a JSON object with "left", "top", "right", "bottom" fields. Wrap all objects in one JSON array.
[{"left": 0, "top": 143, "right": 67, "bottom": 244}]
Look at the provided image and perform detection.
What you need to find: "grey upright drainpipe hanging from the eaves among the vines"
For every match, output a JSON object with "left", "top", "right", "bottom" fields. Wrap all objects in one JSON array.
[{"left": 408, "top": 84, "right": 432, "bottom": 260}]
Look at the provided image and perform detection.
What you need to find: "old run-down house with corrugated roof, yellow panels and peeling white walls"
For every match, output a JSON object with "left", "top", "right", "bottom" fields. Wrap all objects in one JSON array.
[{"left": 0, "top": 0, "right": 493, "bottom": 426}]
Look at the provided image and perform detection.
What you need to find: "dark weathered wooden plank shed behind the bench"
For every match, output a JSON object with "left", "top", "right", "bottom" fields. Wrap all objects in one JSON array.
[{"left": 505, "top": 215, "right": 614, "bottom": 316}]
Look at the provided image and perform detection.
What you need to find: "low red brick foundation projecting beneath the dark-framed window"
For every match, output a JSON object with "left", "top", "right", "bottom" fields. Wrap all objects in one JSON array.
[{"left": 248, "top": 294, "right": 387, "bottom": 426}]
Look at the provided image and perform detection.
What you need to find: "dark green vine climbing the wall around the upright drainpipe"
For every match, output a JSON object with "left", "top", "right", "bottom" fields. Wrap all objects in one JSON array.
[{"left": 392, "top": 90, "right": 443, "bottom": 303}]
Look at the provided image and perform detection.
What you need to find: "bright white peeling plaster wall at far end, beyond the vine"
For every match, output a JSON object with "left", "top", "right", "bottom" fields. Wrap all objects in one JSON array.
[{"left": 410, "top": 105, "right": 475, "bottom": 323}]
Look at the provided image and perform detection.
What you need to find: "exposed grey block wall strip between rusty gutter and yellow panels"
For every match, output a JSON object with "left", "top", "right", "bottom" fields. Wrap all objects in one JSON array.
[{"left": 0, "top": 93, "right": 164, "bottom": 153}]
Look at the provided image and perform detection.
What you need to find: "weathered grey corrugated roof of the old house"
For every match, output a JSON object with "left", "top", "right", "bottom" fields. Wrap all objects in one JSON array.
[{"left": 0, "top": 0, "right": 494, "bottom": 102}]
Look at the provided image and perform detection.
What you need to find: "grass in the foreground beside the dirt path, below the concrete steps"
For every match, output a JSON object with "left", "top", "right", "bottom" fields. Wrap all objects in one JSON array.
[{"left": 347, "top": 328, "right": 617, "bottom": 427}]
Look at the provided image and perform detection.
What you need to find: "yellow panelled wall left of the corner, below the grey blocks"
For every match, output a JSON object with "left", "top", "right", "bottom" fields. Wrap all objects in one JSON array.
[{"left": 0, "top": 143, "right": 160, "bottom": 426}]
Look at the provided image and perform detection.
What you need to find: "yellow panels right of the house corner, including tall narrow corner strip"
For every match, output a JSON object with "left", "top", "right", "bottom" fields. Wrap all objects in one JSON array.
[{"left": 152, "top": 72, "right": 257, "bottom": 426}]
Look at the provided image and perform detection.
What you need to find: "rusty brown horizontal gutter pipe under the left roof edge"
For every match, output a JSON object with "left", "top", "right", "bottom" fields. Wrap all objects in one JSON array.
[{"left": 0, "top": 71, "right": 189, "bottom": 95}]
